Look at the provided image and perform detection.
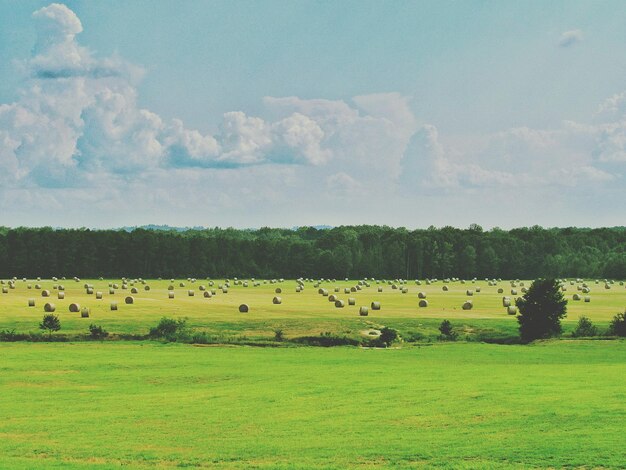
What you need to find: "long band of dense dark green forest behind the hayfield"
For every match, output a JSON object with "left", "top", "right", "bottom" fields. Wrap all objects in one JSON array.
[{"left": 0, "top": 225, "right": 626, "bottom": 279}]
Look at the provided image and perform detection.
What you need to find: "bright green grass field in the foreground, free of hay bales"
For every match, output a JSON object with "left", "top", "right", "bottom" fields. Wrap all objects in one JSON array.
[{"left": 0, "top": 341, "right": 626, "bottom": 469}]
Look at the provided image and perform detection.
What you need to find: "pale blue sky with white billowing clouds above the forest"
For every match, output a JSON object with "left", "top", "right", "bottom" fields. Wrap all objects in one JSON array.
[{"left": 0, "top": 0, "right": 626, "bottom": 229}]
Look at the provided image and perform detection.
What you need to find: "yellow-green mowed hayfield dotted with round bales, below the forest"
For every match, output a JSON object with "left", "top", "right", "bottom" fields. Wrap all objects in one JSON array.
[{"left": 0, "top": 279, "right": 626, "bottom": 339}]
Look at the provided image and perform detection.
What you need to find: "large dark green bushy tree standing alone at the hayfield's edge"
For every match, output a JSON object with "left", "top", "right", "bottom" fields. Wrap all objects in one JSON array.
[{"left": 517, "top": 279, "right": 567, "bottom": 341}]
